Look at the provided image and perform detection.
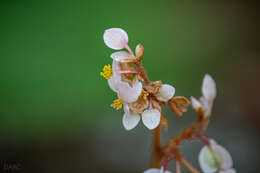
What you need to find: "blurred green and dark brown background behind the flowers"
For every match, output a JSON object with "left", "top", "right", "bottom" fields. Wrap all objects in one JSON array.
[{"left": 0, "top": 0, "right": 260, "bottom": 173}]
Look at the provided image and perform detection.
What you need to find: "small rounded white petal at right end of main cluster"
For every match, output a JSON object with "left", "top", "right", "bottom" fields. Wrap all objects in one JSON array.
[{"left": 157, "top": 84, "right": 175, "bottom": 102}]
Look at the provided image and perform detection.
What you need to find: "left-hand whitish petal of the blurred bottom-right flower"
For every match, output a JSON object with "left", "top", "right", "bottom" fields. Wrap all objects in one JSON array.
[{"left": 199, "top": 146, "right": 218, "bottom": 173}]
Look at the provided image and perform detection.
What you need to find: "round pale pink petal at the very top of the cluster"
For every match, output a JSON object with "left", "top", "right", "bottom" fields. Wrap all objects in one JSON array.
[{"left": 103, "top": 28, "right": 128, "bottom": 50}]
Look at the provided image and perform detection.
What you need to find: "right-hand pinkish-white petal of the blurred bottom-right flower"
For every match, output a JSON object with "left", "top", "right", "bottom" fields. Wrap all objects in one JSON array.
[{"left": 212, "top": 145, "right": 233, "bottom": 169}]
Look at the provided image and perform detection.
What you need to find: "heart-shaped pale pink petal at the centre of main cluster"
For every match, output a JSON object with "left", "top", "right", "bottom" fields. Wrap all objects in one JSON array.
[{"left": 118, "top": 82, "right": 143, "bottom": 103}]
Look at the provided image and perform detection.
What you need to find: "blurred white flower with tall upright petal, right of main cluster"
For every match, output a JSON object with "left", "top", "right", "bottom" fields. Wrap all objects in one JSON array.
[{"left": 191, "top": 74, "right": 216, "bottom": 117}]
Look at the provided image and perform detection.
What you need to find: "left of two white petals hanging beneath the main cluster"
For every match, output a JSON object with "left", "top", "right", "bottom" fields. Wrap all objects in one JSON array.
[{"left": 122, "top": 113, "right": 141, "bottom": 130}]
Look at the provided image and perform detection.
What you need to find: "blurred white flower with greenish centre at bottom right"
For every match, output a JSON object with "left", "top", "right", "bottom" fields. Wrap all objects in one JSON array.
[{"left": 199, "top": 141, "right": 234, "bottom": 173}]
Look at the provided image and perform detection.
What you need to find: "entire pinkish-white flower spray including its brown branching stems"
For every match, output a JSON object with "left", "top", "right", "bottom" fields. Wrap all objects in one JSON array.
[{"left": 100, "top": 28, "right": 236, "bottom": 173}]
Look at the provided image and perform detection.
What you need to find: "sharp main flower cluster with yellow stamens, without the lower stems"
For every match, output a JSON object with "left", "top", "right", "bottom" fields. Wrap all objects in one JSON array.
[{"left": 100, "top": 28, "right": 175, "bottom": 130}]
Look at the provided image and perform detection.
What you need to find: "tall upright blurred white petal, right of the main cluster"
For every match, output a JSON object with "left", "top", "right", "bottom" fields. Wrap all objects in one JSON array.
[{"left": 201, "top": 74, "right": 216, "bottom": 101}]
